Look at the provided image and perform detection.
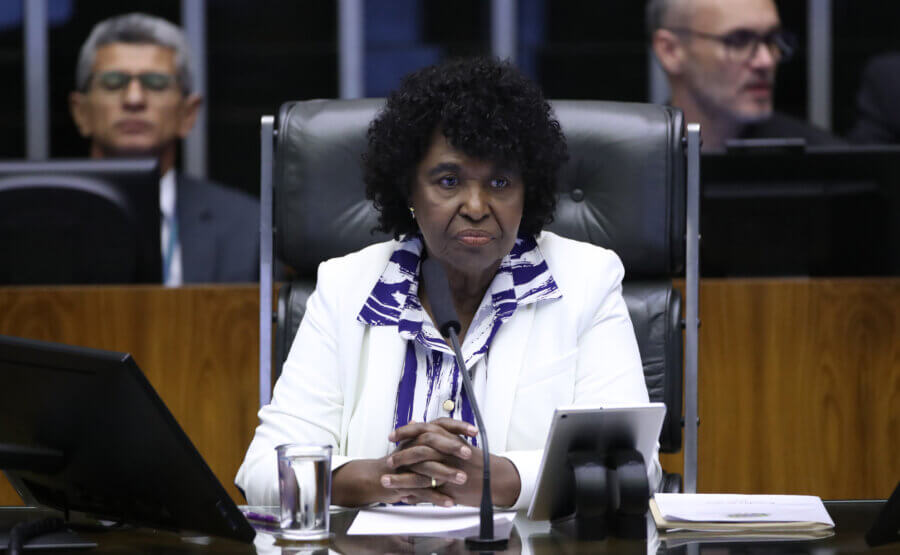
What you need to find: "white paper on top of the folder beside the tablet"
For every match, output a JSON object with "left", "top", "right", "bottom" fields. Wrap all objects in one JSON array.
[{"left": 654, "top": 493, "right": 834, "bottom": 526}]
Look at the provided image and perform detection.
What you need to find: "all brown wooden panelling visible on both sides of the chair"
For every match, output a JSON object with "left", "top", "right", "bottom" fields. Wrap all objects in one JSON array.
[{"left": 0, "top": 278, "right": 900, "bottom": 504}]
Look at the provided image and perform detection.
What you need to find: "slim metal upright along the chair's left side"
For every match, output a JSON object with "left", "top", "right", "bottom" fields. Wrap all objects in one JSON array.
[{"left": 259, "top": 116, "right": 275, "bottom": 408}]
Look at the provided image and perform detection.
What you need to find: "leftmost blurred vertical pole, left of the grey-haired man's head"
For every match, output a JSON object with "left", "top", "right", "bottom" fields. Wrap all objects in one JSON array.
[{"left": 22, "top": 0, "right": 50, "bottom": 160}]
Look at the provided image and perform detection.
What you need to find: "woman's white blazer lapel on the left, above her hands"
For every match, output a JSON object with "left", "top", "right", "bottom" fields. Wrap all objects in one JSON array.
[{"left": 347, "top": 326, "right": 406, "bottom": 456}]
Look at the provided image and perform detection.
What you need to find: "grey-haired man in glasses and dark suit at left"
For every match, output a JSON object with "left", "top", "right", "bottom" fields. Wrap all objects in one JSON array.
[{"left": 69, "top": 13, "right": 259, "bottom": 285}]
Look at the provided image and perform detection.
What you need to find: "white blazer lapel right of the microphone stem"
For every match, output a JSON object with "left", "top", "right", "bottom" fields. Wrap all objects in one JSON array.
[{"left": 482, "top": 303, "right": 536, "bottom": 452}]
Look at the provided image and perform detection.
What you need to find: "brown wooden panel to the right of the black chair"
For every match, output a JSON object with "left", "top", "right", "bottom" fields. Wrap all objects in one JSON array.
[{"left": 698, "top": 278, "right": 900, "bottom": 499}]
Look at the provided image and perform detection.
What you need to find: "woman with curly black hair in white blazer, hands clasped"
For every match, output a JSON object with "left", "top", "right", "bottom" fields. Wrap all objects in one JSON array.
[{"left": 236, "top": 59, "right": 661, "bottom": 509}]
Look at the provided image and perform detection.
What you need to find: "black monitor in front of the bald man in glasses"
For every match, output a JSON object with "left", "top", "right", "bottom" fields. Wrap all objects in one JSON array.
[{"left": 700, "top": 144, "right": 900, "bottom": 277}]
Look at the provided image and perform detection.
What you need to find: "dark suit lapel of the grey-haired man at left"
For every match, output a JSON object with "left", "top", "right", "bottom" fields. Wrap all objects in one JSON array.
[{"left": 175, "top": 175, "right": 216, "bottom": 283}]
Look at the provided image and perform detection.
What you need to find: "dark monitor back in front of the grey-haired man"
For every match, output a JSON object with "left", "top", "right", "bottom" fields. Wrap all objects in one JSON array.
[{"left": 0, "top": 159, "right": 162, "bottom": 285}]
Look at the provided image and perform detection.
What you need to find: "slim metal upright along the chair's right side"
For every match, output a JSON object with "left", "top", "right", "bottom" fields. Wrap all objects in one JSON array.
[{"left": 684, "top": 123, "right": 700, "bottom": 493}]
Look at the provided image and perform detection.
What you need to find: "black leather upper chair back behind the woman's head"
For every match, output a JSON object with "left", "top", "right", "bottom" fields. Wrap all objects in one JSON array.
[{"left": 274, "top": 99, "right": 685, "bottom": 278}]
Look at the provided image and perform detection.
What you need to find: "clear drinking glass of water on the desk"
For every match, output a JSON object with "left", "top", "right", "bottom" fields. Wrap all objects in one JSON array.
[{"left": 275, "top": 444, "right": 331, "bottom": 540}]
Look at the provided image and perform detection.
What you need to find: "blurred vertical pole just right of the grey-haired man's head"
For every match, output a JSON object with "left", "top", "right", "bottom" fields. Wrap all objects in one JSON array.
[{"left": 181, "top": 0, "right": 208, "bottom": 177}]
